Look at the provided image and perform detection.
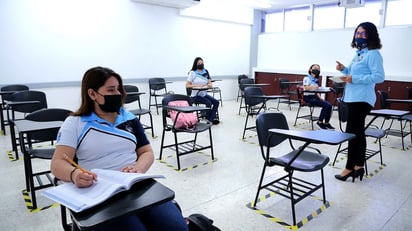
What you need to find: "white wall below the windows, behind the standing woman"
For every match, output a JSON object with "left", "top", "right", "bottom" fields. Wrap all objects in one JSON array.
[{"left": 256, "top": 27, "right": 412, "bottom": 81}]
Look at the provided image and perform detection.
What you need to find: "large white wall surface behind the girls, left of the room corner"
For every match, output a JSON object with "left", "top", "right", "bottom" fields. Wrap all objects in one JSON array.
[{"left": 0, "top": 0, "right": 251, "bottom": 85}]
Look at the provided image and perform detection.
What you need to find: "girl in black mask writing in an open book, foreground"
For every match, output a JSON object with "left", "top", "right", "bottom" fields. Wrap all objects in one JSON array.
[{"left": 51, "top": 67, "right": 188, "bottom": 230}]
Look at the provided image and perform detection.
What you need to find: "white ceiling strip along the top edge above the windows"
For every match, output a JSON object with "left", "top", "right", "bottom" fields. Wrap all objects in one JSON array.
[{"left": 132, "top": 0, "right": 338, "bottom": 11}]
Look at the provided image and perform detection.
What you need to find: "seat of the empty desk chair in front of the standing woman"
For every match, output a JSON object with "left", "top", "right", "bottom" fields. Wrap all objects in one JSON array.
[{"left": 269, "top": 150, "right": 329, "bottom": 172}]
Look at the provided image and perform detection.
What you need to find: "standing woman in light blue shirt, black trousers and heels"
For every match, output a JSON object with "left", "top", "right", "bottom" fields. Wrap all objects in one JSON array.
[{"left": 335, "top": 22, "right": 385, "bottom": 181}]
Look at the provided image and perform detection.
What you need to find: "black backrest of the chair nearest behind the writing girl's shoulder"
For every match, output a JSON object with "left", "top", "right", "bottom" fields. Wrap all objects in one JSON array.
[{"left": 25, "top": 108, "right": 72, "bottom": 142}]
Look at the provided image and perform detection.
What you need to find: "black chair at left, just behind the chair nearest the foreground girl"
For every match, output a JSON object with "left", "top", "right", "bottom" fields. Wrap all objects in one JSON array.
[{"left": 7, "top": 90, "right": 47, "bottom": 159}]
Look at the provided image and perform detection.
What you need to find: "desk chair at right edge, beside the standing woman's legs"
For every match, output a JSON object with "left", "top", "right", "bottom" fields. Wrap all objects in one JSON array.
[{"left": 366, "top": 109, "right": 411, "bottom": 150}]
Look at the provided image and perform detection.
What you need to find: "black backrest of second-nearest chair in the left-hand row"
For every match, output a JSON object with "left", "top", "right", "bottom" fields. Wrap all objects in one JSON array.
[{"left": 10, "top": 90, "right": 47, "bottom": 113}]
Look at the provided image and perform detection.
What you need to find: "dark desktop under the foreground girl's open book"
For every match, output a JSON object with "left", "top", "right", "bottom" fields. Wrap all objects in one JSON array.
[{"left": 70, "top": 179, "right": 175, "bottom": 230}]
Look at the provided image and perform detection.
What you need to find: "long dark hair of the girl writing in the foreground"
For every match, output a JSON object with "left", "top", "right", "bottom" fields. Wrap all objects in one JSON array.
[{"left": 73, "top": 67, "right": 126, "bottom": 116}]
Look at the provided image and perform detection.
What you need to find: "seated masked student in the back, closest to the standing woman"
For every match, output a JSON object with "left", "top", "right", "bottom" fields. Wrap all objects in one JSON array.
[{"left": 303, "top": 64, "right": 335, "bottom": 129}]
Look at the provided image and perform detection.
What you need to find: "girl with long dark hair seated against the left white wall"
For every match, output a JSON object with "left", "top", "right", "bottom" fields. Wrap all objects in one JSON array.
[{"left": 186, "top": 57, "right": 219, "bottom": 124}]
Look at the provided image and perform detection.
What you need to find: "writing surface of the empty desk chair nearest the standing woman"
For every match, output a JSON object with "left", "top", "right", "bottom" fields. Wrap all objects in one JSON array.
[{"left": 269, "top": 129, "right": 355, "bottom": 145}]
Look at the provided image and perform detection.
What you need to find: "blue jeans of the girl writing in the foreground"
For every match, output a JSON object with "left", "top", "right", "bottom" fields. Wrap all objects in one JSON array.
[{"left": 95, "top": 201, "right": 188, "bottom": 231}]
